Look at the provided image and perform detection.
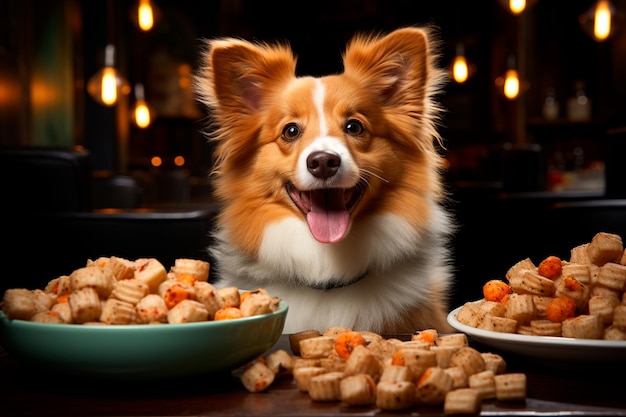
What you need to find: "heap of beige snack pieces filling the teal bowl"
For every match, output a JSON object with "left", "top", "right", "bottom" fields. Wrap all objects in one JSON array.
[{"left": 0, "top": 256, "right": 280, "bottom": 325}]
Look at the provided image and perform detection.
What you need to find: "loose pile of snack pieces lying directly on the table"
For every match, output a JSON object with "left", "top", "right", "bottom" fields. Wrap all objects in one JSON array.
[{"left": 241, "top": 327, "right": 526, "bottom": 414}]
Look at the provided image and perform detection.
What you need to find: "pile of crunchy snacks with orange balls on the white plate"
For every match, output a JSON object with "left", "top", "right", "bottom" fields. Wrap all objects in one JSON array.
[{"left": 456, "top": 232, "right": 626, "bottom": 340}]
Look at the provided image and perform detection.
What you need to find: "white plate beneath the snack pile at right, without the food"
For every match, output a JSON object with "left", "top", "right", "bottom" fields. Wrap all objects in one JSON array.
[{"left": 448, "top": 307, "right": 626, "bottom": 363}]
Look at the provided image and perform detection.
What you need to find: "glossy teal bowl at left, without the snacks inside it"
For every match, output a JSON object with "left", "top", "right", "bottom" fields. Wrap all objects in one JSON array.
[{"left": 0, "top": 300, "right": 288, "bottom": 379}]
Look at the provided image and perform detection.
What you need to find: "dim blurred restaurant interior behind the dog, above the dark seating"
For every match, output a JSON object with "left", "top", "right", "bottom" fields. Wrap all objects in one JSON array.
[{"left": 0, "top": 0, "right": 626, "bottom": 190}]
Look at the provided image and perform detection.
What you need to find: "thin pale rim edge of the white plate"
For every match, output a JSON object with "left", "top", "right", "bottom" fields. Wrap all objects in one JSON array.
[{"left": 447, "top": 306, "right": 626, "bottom": 349}]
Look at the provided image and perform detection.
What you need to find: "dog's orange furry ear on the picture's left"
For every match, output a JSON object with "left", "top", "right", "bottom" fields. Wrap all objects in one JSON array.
[{"left": 194, "top": 38, "right": 296, "bottom": 115}]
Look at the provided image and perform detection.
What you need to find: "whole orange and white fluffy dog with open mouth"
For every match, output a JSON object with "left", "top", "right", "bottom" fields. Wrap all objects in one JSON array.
[{"left": 195, "top": 27, "right": 452, "bottom": 334}]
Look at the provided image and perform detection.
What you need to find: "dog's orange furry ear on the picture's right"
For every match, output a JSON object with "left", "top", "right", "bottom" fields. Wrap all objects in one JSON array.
[{"left": 343, "top": 27, "right": 440, "bottom": 106}]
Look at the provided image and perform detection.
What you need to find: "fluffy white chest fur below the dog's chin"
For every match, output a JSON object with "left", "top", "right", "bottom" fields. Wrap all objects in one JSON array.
[{"left": 215, "top": 208, "right": 449, "bottom": 333}]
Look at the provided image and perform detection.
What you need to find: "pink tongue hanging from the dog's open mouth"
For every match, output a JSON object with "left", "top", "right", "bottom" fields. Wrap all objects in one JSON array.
[{"left": 306, "top": 189, "right": 350, "bottom": 243}]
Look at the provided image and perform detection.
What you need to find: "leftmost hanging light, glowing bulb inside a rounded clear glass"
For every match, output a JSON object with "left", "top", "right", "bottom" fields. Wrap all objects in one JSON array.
[{"left": 87, "top": 45, "right": 130, "bottom": 106}]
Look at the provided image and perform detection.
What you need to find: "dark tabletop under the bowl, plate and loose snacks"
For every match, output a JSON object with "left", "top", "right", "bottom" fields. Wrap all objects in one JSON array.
[{"left": 0, "top": 335, "right": 626, "bottom": 417}]
